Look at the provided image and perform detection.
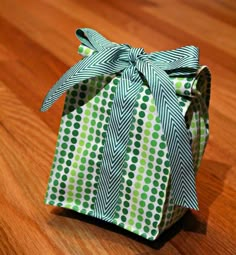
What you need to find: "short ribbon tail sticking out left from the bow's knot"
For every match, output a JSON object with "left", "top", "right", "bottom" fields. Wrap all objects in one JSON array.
[{"left": 41, "top": 47, "right": 126, "bottom": 112}]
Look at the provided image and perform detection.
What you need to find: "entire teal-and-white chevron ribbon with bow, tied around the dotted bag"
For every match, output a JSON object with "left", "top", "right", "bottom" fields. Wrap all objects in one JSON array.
[{"left": 41, "top": 28, "right": 199, "bottom": 213}]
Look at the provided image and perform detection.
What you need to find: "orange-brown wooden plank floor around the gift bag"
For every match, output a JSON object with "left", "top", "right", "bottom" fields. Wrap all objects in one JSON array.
[{"left": 0, "top": 0, "right": 236, "bottom": 255}]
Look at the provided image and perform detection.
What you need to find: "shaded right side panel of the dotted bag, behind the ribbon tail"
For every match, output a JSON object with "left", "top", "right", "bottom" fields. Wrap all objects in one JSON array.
[{"left": 159, "top": 66, "right": 210, "bottom": 233}]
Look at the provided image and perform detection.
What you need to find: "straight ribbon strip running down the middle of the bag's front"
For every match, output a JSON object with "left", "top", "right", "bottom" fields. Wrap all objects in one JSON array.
[{"left": 94, "top": 66, "right": 143, "bottom": 219}]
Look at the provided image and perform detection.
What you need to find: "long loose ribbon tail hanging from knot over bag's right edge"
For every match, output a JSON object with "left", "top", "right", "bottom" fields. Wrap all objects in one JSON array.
[{"left": 136, "top": 59, "right": 198, "bottom": 210}]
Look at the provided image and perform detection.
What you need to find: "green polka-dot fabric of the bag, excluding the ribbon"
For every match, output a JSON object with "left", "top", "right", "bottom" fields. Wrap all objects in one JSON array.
[{"left": 45, "top": 46, "right": 210, "bottom": 240}]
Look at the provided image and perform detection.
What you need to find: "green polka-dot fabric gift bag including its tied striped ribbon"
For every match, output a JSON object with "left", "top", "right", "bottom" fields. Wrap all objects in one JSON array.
[{"left": 41, "top": 29, "right": 210, "bottom": 240}]
